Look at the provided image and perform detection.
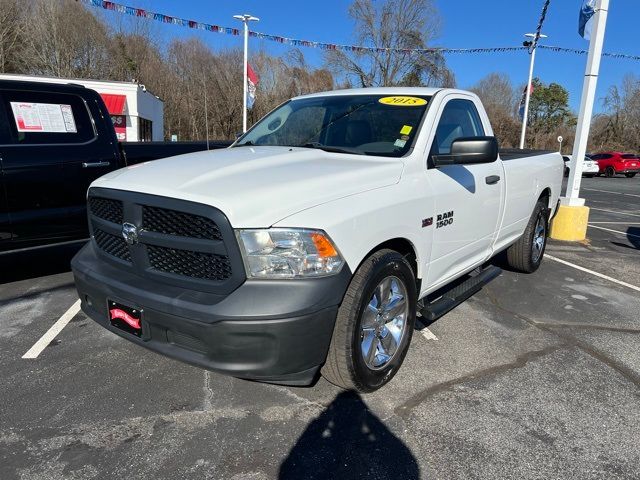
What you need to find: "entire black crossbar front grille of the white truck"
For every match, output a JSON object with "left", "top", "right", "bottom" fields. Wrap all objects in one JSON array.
[{"left": 89, "top": 187, "right": 246, "bottom": 295}]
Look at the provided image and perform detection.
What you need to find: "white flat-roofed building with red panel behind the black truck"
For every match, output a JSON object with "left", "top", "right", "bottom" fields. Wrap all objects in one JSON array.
[{"left": 0, "top": 74, "right": 164, "bottom": 142}]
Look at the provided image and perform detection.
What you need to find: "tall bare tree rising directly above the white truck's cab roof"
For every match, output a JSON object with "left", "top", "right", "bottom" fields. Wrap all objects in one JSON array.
[{"left": 326, "top": 0, "right": 455, "bottom": 87}]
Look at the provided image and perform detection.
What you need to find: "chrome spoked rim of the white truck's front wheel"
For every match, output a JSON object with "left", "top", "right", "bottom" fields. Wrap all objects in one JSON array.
[{"left": 360, "top": 276, "right": 409, "bottom": 370}]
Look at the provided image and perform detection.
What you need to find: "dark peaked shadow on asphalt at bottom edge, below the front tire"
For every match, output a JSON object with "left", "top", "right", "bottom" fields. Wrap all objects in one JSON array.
[{"left": 278, "top": 392, "right": 420, "bottom": 480}]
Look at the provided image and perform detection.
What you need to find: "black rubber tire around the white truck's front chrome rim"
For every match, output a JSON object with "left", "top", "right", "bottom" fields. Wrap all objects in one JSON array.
[{"left": 322, "top": 250, "right": 417, "bottom": 392}]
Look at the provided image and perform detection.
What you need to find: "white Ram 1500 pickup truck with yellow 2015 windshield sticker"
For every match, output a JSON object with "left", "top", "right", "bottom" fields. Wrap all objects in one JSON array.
[{"left": 72, "top": 88, "right": 563, "bottom": 392}]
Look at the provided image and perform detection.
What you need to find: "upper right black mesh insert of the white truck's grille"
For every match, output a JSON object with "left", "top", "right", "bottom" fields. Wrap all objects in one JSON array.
[{"left": 142, "top": 206, "right": 222, "bottom": 240}]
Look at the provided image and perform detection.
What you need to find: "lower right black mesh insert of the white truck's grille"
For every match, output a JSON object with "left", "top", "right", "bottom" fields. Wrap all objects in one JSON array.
[{"left": 147, "top": 245, "right": 231, "bottom": 281}]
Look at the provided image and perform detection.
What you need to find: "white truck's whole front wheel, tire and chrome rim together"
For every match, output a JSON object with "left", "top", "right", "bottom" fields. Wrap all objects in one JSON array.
[{"left": 322, "top": 250, "right": 417, "bottom": 392}]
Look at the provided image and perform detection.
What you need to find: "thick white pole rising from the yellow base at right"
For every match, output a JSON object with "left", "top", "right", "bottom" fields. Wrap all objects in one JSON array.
[{"left": 560, "top": 0, "right": 609, "bottom": 206}]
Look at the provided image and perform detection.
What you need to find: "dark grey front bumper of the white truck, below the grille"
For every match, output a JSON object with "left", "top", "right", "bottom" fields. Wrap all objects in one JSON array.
[{"left": 71, "top": 242, "right": 351, "bottom": 385}]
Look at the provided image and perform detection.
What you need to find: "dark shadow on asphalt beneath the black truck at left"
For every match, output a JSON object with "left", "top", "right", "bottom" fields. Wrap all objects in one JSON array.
[{"left": 0, "top": 242, "right": 84, "bottom": 284}]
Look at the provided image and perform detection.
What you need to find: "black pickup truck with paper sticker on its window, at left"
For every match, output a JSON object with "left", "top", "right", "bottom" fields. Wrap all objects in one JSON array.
[{"left": 0, "top": 80, "right": 226, "bottom": 254}]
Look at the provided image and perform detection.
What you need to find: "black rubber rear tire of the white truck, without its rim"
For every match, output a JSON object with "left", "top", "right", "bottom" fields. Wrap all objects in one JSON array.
[{"left": 507, "top": 200, "right": 549, "bottom": 273}]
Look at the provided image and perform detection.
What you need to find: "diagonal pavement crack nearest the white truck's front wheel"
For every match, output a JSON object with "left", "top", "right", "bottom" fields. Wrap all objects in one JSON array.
[{"left": 395, "top": 344, "right": 567, "bottom": 418}]
